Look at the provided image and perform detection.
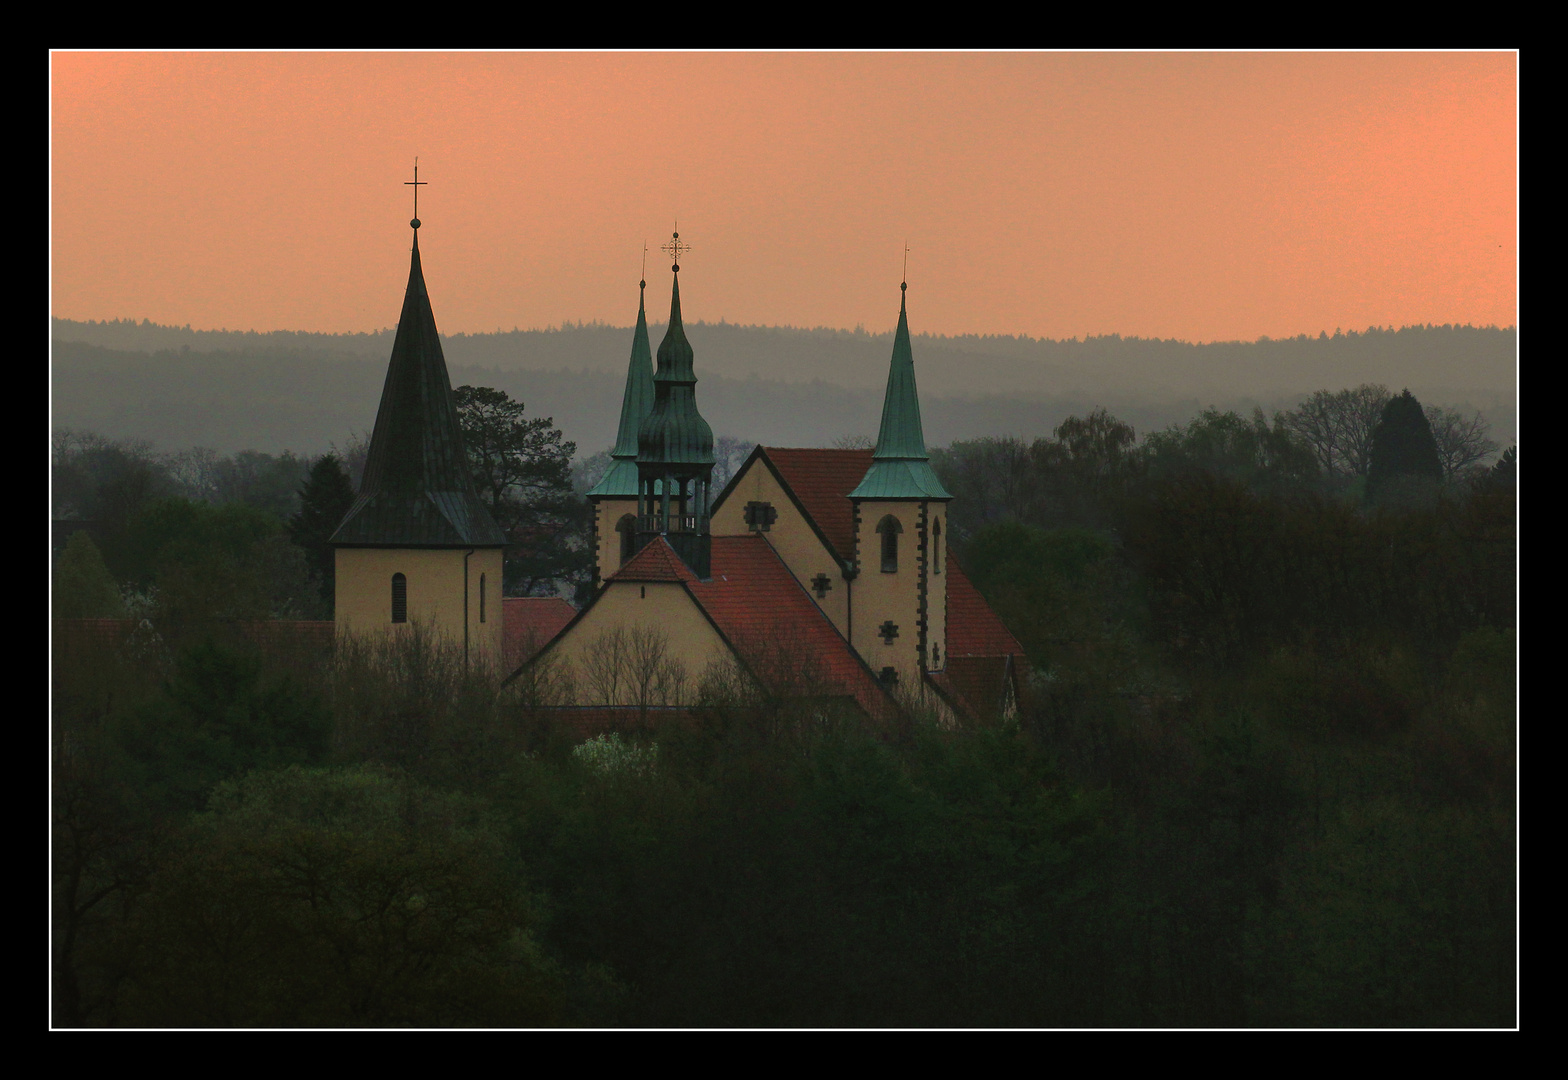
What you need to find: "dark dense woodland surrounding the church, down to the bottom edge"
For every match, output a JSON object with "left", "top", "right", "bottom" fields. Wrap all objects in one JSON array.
[{"left": 52, "top": 384, "right": 1518, "bottom": 1027}]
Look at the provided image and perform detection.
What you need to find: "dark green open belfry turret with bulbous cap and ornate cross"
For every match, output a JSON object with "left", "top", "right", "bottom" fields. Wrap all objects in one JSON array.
[{"left": 637, "top": 232, "right": 713, "bottom": 582}]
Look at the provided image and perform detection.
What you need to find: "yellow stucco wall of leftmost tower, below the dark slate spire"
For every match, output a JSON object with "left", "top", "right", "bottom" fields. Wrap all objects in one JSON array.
[{"left": 336, "top": 547, "right": 503, "bottom": 658}]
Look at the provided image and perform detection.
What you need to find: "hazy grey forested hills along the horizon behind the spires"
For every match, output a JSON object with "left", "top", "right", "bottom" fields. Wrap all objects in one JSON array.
[{"left": 52, "top": 318, "right": 1518, "bottom": 453}]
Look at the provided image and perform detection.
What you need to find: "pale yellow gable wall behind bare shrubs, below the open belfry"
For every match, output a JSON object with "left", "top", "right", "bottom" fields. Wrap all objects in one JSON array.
[{"left": 546, "top": 582, "right": 731, "bottom": 705}]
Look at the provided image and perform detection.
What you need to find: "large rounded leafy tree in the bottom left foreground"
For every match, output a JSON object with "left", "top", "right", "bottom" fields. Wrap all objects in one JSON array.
[{"left": 108, "top": 768, "right": 563, "bottom": 1027}]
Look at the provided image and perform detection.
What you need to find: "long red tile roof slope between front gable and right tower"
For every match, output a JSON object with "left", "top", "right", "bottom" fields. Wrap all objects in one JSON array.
[{"left": 687, "top": 535, "right": 892, "bottom": 719}]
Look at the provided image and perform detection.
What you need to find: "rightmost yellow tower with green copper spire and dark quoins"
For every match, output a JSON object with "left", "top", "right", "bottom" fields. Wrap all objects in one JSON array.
[{"left": 850, "top": 282, "right": 952, "bottom": 687}]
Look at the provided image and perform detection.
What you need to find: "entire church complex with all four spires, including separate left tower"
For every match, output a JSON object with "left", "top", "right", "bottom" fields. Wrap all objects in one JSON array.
[{"left": 331, "top": 205, "right": 1024, "bottom": 723}]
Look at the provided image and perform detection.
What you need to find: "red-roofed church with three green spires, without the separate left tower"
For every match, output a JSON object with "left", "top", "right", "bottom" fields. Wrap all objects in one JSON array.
[{"left": 514, "top": 234, "right": 1024, "bottom": 719}]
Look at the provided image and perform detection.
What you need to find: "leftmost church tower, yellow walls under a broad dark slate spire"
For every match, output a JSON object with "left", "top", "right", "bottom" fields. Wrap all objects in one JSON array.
[{"left": 329, "top": 178, "right": 506, "bottom": 660}]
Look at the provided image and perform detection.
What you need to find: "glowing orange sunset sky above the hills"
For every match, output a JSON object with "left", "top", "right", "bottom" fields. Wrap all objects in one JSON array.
[{"left": 50, "top": 53, "right": 1518, "bottom": 340}]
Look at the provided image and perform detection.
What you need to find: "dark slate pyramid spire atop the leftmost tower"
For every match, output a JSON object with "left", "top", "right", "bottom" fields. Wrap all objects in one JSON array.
[{"left": 331, "top": 218, "right": 506, "bottom": 547}]
